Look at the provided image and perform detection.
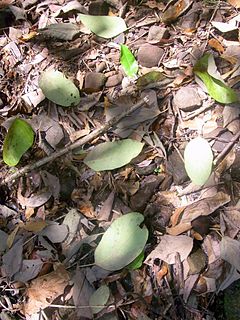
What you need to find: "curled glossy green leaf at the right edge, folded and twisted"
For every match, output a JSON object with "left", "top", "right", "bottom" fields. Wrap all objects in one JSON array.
[{"left": 193, "top": 54, "right": 239, "bottom": 104}]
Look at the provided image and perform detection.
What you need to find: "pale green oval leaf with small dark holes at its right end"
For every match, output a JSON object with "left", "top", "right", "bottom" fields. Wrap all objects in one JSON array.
[{"left": 39, "top": 70, "right": 80, "bottom": 107}]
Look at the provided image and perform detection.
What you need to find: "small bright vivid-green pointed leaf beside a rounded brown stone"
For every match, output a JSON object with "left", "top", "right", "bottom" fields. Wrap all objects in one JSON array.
[{"left": 120, "top": 44, "right": 138, "bottom": 77}]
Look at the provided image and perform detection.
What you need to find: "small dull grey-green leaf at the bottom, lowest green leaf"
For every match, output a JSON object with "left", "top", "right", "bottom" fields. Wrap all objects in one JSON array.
[{"left": 89, "top": 285, "right": 110, "bottom": 314}]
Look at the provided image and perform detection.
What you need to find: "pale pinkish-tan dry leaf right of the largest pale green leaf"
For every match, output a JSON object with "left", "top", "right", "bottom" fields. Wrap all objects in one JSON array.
[{"left": 145, "top": 235, "right": 193, "bottom": 265}]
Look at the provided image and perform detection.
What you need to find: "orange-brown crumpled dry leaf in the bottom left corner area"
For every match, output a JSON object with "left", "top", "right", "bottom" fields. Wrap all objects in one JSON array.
[{"left": 24, "top": 265, "right": 69, "bottom": 316}]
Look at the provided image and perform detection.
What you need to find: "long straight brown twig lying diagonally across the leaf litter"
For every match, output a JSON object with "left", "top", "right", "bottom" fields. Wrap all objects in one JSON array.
[{"left": 2, "top": 96, "right": 149, "bottom": 184}]
